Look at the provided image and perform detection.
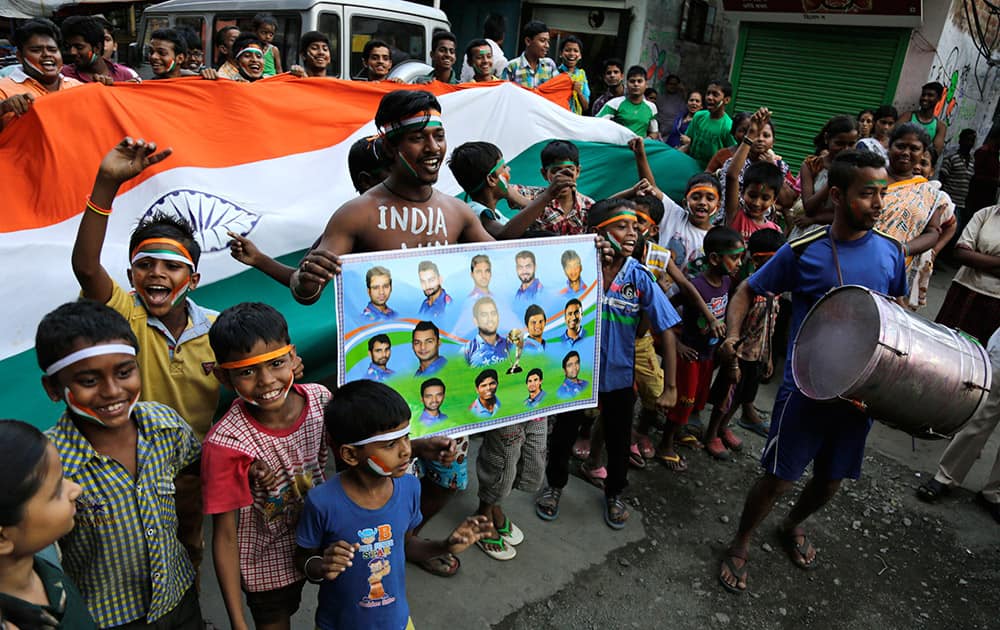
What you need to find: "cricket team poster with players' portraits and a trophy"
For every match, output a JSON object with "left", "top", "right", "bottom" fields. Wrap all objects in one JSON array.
[{"left": 336, "top": 237, "right": 602, "bottom": 438}]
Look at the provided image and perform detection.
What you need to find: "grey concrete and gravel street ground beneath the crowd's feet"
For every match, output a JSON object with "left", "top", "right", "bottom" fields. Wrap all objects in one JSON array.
[{"left": 202, "top": 266, "right": 1000, "bottom": 630}]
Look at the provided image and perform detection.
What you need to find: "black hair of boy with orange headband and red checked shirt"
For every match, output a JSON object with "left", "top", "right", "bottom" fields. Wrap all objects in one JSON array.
[{"left": 208, "top": 302, "right": 291, "bottom": 363}]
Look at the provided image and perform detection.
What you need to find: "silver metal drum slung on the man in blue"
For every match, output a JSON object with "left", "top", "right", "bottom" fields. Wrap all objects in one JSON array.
[{"left": 792, "top": 285, "right": 992, "bottom": 438}]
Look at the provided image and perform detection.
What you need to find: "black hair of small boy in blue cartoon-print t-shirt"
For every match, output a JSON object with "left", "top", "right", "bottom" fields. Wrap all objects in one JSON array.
[{"left": 323, "top": 379, "right": 411, "bottom": 446}]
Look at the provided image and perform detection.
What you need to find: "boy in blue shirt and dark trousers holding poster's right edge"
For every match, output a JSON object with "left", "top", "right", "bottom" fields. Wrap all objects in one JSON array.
[{"left": 535, "top": 199, "right": 680, "bottom": 529}]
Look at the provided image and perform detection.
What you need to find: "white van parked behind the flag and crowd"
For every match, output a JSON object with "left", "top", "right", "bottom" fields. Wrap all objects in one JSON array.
[{"left": 128, "top": 0, "right": 450, "bottom": 79}]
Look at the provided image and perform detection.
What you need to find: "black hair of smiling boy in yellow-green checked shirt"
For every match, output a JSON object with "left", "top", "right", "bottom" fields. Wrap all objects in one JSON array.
[{"left": 35, "top": 300, "right": 139, "bottom": 372}]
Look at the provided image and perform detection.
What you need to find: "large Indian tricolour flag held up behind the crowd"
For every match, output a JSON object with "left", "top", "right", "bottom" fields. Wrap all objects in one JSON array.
[{"left": 0, "top": 76, "right": 697, "bottom": 427}]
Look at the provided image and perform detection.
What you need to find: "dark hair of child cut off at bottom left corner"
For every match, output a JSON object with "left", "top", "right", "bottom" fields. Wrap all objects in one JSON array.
[{"left": 0, "top": 419, "right": 49, "bottom": 527}]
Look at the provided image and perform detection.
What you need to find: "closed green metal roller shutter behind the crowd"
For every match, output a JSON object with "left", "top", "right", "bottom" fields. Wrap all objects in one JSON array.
[{"left": 729, "top": 22, "right": 910, "bottom": 172}]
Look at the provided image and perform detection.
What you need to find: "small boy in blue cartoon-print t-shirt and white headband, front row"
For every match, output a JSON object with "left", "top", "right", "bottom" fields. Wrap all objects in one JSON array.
[{"left": 296, "top": 380, "right": 492, "bottom": 630}]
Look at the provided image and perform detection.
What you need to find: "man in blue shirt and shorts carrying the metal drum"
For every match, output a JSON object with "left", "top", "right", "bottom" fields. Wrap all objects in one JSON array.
[{"left": 719, "top": 150, "right": 907, "bottom": 593}]
